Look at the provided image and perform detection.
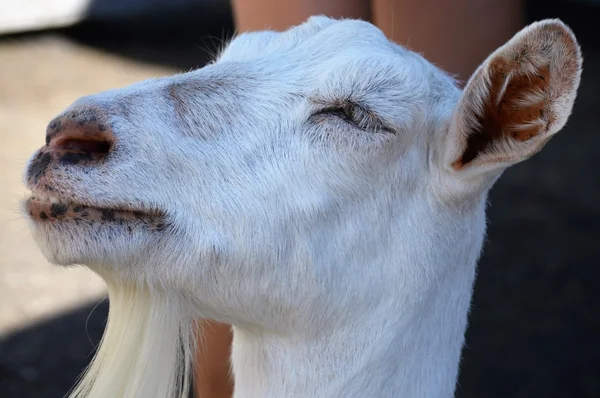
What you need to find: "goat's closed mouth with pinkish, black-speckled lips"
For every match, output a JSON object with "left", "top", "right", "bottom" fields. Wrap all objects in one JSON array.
[{"left": 24, "top": 192, "right": 167, "bottom": 231}]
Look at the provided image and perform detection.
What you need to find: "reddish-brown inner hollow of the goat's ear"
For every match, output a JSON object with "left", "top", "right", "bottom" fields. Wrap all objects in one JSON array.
[{"left": 454, "top": 57, "right": 552, "bottom": 168}]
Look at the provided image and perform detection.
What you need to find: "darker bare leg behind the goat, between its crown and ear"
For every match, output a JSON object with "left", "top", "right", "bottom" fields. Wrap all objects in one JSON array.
[{"left": 372, "top": 0, "right": 524, "bottom": 80}]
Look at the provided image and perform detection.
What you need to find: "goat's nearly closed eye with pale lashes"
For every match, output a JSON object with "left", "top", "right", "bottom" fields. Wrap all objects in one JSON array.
[{"left": 313, "top": 101, "right": 393, "bottom": 133}]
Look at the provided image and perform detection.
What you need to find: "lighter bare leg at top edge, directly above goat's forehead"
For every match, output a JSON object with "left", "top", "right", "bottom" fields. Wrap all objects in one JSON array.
[{"left": 232, "top": 0, "right": 370, "bottom": 32}]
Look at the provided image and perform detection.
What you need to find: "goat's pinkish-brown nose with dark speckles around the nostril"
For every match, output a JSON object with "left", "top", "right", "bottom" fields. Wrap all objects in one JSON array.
[{"left": 46, "top": 109, "right": 115, "bottom": 163}]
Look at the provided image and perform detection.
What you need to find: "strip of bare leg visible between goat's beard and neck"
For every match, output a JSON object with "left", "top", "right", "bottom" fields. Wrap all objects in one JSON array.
[{"left": 194, "top": 321, "right": 233, "bottom": 398}]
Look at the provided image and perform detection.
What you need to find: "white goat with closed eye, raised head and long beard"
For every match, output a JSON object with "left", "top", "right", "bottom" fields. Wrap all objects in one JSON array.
[{"left": 24, "top": 17, "right": 582, "bottom": 398}]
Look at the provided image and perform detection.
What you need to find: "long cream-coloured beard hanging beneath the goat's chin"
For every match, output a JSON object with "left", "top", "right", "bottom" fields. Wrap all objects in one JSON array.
[{"left": 69, "top": 282, "right": 196, "bottom": 398}]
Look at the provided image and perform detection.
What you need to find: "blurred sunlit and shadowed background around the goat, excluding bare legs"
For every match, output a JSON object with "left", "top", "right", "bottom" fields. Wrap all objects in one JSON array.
[{"left": 0, "top": 0, "right": 600, "bottom": 398}]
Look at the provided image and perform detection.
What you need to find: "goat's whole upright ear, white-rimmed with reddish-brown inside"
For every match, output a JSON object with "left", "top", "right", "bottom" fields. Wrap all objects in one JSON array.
[{"left": 444, "top": 20, "right": 582, "bottom": 175}]
